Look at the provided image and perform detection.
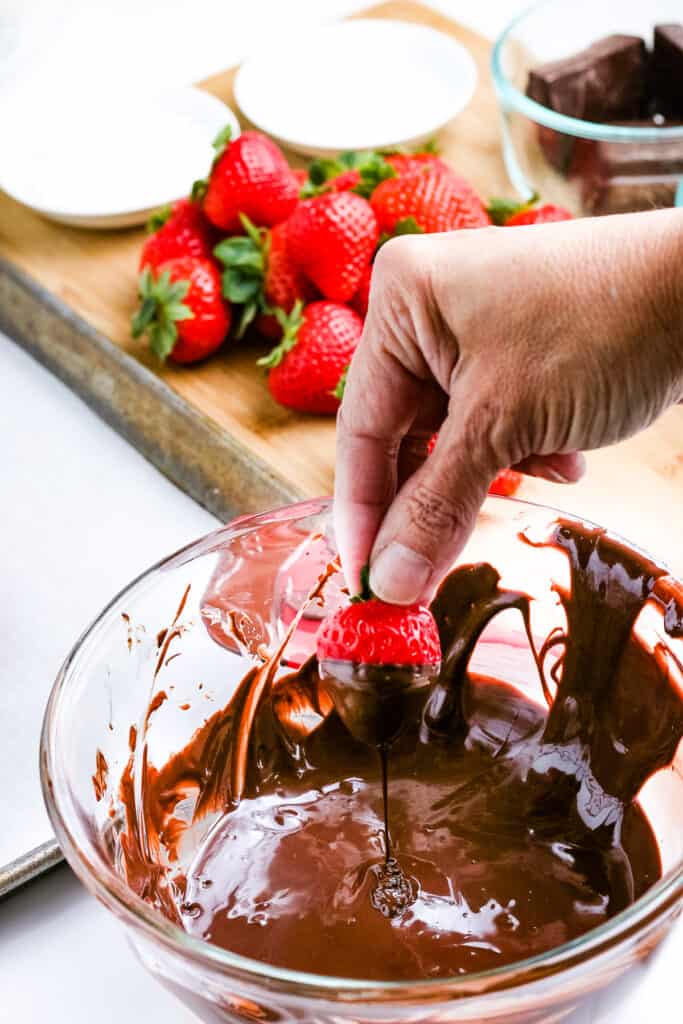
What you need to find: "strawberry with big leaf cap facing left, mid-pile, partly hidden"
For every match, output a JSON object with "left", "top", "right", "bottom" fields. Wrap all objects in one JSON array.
[{"left": 214, "top": 214, "right": 313, "bottom": 338}]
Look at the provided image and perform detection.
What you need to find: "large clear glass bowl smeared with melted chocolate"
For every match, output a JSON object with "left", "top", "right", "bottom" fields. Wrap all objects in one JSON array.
[{"left": 41, "top": 498, "right": 683, "bottom": 1024}]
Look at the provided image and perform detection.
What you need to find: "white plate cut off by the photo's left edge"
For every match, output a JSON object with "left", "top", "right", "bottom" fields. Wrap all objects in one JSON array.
[{"left": 0, "top": 88, "right": 240, "bottom": 227}]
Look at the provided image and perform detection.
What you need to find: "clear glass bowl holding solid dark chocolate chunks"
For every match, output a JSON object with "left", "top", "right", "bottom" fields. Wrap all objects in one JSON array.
[{"left": 492, "top": 0, "right": 683, "bottom": 215}]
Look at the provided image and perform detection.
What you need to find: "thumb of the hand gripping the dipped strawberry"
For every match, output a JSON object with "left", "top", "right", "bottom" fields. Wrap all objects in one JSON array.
[{"left": 370, "top": 405, "right": 501, "bottom": 604}]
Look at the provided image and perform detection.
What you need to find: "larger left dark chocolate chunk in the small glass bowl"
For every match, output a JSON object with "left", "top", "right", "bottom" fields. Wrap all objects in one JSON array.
[{"left": 526, "top": 35, "right": 647, "bottom": 121}]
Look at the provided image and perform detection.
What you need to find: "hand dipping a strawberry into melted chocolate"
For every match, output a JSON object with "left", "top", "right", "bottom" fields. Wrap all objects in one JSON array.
[{"left": 335, "top": 210, "right": 683, "bottom": 604}]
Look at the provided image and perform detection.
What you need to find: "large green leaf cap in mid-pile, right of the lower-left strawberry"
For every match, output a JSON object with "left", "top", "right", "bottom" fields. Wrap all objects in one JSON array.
[{"left": 213, "top": 213, "right": 270, "bottom": 338}]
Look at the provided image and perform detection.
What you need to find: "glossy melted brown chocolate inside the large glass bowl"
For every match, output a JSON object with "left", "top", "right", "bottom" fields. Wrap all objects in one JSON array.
[{"left": 114, "top": 521, "right": 683, "bottom": 980}]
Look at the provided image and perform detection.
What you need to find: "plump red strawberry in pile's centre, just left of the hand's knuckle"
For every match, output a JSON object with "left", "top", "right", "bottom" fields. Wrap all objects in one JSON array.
[{"left": 287, "top": 191, "right": 379, "bottom": 302}]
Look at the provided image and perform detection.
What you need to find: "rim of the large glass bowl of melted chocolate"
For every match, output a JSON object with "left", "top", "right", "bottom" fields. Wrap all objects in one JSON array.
[{"left": 40, "top": 495, "right": 683, "bottom": 1002}]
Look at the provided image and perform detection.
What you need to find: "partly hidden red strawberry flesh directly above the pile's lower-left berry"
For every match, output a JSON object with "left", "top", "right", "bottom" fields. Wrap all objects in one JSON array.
[{"left": 139, "top": 199, "right": 215, "bottom": 270}]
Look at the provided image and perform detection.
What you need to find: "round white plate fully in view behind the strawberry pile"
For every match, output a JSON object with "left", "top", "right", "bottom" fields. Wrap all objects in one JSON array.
[{"left": 234, "top": 18, "right": 477, "bottom": 156}]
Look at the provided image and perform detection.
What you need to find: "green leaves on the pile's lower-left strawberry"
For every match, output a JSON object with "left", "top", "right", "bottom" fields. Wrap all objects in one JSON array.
[{"left": 131, "top": 267, "right": 195, "bottom": 362}]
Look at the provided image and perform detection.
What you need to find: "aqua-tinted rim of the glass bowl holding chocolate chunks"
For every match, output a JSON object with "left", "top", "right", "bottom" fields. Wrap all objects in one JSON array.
[{"left": 490, "top": 0, "right": 683, "bottom": 142}]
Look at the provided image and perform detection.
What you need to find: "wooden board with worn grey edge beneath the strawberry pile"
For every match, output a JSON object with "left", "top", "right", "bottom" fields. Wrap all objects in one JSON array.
[{"left": 0, "top": 0, "right": 683, "bottom": 571}]
